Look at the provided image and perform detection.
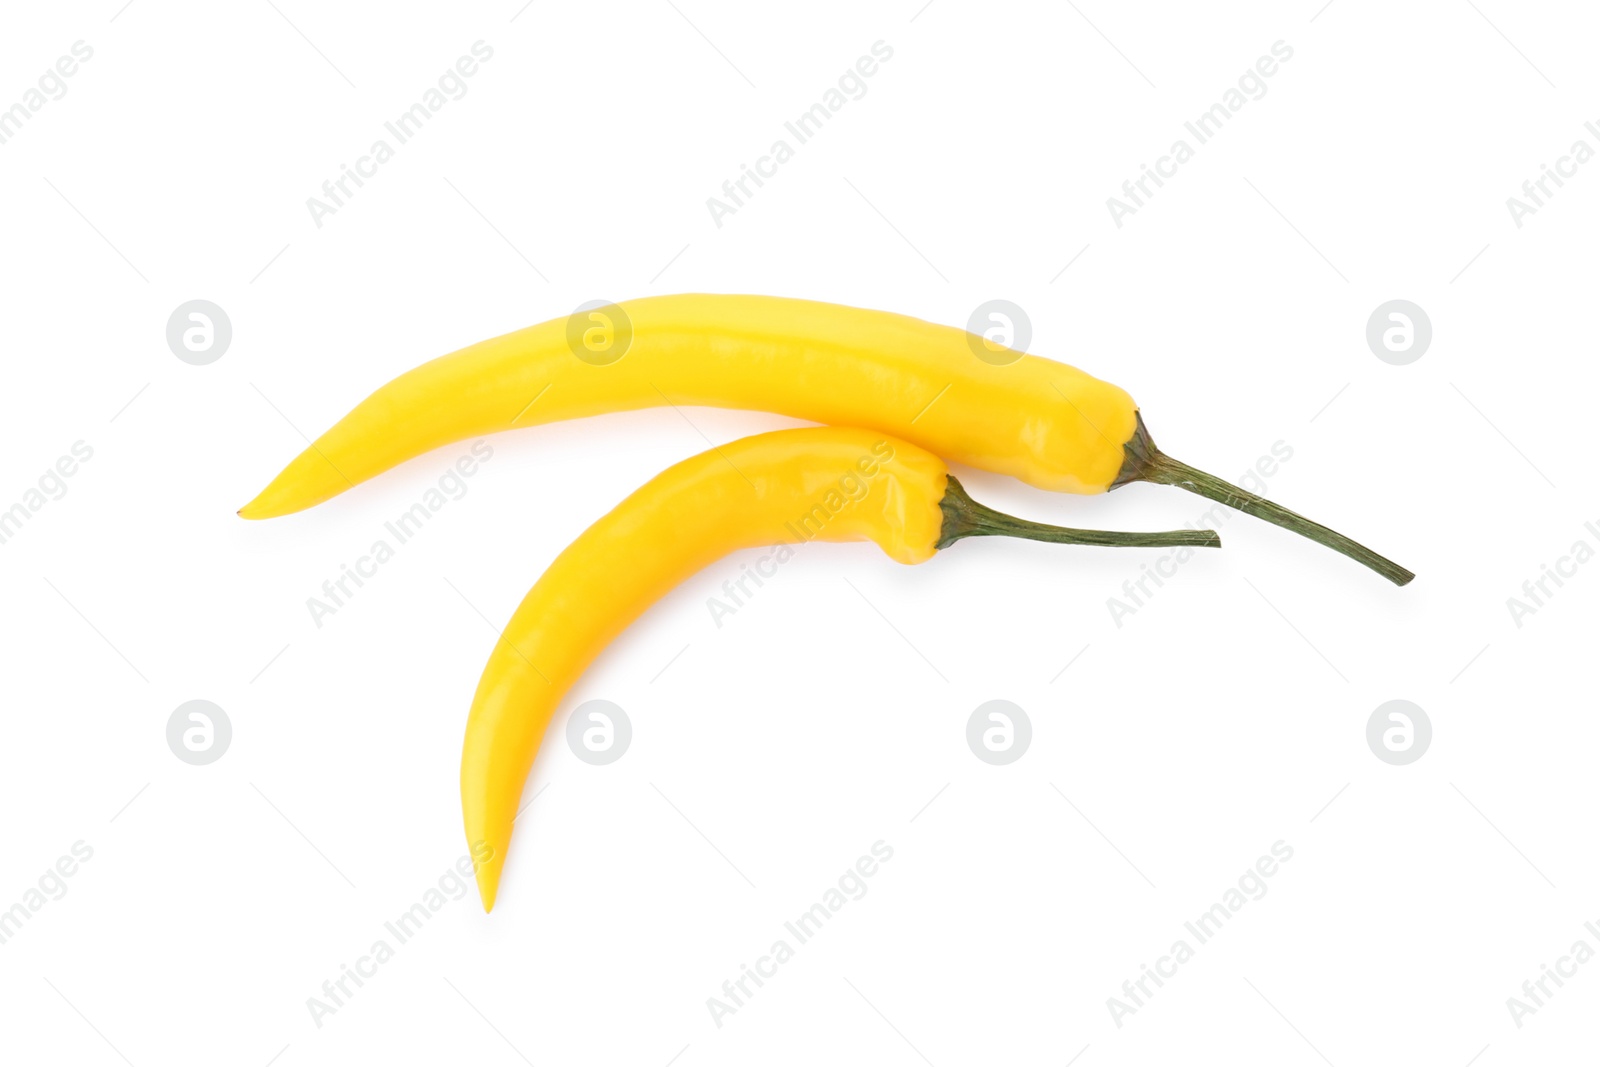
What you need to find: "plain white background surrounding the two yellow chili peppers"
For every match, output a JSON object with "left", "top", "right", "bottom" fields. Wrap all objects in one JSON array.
[{"left": 0, "top": 0, "right": 1600, "bottom": 1067}]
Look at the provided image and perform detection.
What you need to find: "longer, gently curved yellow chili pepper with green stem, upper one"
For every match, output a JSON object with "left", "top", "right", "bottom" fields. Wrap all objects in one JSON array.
[{"left": 238, "top": 294, "right": 1413, "bottom": 585}]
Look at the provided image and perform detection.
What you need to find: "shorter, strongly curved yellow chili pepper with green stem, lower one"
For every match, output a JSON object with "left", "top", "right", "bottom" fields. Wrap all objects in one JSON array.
[{"left": 461, "top": 427, "right": 1221, "bottom": 910}]
